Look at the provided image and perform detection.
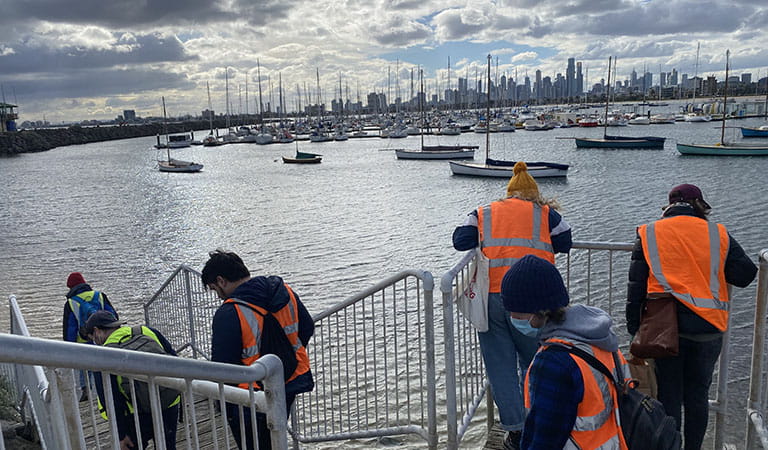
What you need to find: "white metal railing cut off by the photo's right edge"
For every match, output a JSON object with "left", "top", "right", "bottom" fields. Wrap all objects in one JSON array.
[{"left": 745, "top": 249, "right": 768, "bottom": 450}]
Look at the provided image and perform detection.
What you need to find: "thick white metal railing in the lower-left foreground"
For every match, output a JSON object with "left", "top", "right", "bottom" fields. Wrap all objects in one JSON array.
[{"left": 0, "top": 296, "right": 288, "bottom": 450}]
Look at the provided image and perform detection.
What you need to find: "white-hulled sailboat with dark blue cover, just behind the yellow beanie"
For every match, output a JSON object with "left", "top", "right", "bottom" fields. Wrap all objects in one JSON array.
[{"left": 449, "top": 55, "right": 568, "bottom": 178}]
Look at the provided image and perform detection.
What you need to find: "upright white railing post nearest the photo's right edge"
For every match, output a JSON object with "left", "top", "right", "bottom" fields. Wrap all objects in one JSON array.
[{"left": 746, "top": 250, "right": 768, "bottom": 450}]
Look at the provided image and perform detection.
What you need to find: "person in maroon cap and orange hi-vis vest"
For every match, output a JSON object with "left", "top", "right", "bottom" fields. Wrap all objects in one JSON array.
[{"left": 626, "top": 184, "right": 757, "bottom": 450}]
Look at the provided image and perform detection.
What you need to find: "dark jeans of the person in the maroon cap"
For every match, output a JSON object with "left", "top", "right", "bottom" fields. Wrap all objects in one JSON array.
[{"left": 656, "top": 337, "right": 723, "bottom": 450}]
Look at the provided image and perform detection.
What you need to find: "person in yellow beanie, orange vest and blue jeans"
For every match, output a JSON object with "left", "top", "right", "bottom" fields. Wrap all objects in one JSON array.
[{"left": 453, "top": 161, "right": 572, "bottom": 450}]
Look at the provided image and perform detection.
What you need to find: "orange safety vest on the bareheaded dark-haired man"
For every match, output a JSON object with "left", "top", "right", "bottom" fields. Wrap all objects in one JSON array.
[{"left": 224, "top": 284, "right": 309, "bottom": 389}]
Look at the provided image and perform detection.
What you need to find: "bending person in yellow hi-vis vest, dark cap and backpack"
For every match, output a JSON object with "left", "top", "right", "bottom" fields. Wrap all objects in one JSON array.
[{"left": 83, "top": 310, "right": 181, "bottom": 450}]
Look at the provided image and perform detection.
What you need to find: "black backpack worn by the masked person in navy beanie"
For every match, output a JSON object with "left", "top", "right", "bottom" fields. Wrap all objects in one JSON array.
[{"left": 547, "top": 345, "right": 682, "bottom": 450}]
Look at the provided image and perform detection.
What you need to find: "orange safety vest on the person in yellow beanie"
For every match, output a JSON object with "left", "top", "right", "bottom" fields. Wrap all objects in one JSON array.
[{"left": 477, "top": 198, "right": 555, "bottom": 294}]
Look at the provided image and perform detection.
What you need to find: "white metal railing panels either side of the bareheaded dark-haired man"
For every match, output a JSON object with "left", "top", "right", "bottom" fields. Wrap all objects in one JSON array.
[{"left": 144, "top": 266, "right": 437, "bottom": 448}]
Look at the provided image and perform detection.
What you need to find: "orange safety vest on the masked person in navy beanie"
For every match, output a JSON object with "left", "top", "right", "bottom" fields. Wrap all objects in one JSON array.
[{"left": 524, "top": 338, "right": 629, "bottom": 450}]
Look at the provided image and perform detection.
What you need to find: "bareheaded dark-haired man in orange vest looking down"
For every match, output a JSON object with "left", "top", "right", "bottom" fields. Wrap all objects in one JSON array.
[{"left": 201, "top": 250, "right": 315, "bottom": 450}]
